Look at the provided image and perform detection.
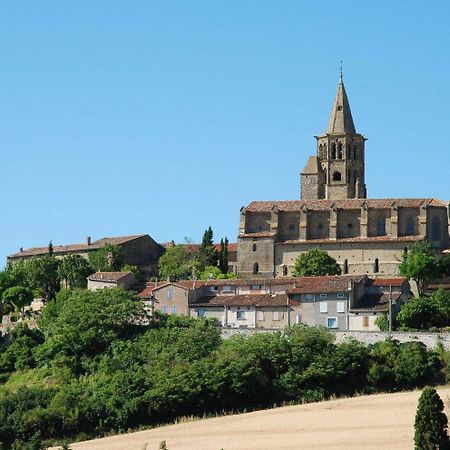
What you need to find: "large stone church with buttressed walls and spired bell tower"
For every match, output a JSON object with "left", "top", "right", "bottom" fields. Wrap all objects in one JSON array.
[{"left": 237, "top": 74, "right": 450, "bottom": 277}]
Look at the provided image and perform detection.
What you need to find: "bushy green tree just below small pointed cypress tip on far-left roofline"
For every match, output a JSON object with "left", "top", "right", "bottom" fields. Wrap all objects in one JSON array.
[{"left": 25, "top": 255, "right": 60, "bottom": 301}]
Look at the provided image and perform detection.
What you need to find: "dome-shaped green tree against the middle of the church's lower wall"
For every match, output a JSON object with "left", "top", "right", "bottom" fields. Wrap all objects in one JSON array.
[{"left": 292, "top": 247, "right": 341, "bottom": 277}]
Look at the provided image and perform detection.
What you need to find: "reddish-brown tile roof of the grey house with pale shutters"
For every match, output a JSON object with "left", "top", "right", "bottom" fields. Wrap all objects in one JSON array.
[{"left": 287, "top": 275, "right": 366, "bottom": 295}]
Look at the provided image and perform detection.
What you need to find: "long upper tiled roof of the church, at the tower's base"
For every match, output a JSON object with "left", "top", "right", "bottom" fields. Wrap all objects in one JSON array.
[{"left": 245, "top": 198, "right": 447, "bottom": 212}]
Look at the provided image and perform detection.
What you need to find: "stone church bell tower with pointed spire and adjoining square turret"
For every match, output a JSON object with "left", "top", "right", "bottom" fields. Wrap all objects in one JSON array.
[{"left": 300, "top": 73, "right": 367, "bottom": 200}]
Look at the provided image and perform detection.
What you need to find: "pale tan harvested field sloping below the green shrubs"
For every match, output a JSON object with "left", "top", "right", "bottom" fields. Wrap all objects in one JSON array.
[{"left": 67, "top": 387, "right": 450, "bottom": 450}]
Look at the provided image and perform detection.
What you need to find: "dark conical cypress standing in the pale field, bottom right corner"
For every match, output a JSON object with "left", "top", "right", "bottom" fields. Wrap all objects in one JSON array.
[{"left": 414, "top": 387, "right": 450, "bottom": 450}]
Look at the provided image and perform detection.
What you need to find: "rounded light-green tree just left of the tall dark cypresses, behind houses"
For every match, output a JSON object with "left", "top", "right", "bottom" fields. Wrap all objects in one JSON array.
[{"left": 158, "top": 245, "right": 196, "bottom": 280}]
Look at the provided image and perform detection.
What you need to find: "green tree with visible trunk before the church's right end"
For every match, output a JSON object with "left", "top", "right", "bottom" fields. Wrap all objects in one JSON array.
[{"left": 399, "top": 241, "right": 439, "bottom": 297}]
